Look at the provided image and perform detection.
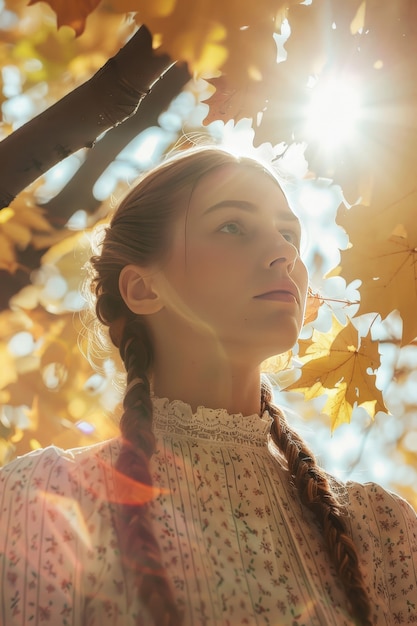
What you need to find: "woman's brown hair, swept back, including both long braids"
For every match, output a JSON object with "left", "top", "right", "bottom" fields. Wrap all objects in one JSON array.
[{"left": 91, "top": 147, "right": 371, "bottom": 626}]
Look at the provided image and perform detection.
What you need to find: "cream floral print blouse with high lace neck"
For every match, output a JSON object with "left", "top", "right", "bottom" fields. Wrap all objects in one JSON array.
[{"left": 0, "top": 399, "right": 417, "bottom": 626}]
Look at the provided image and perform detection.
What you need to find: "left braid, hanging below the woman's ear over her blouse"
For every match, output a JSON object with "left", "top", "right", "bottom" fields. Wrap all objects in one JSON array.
[{"left": 112, "top": 318, "right": 182, "bottom": 626}]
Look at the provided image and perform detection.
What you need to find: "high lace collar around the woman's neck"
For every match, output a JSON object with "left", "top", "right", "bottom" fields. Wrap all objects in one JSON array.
[{"left": 152, "top": 397, "right": 272, "bottom": 446}]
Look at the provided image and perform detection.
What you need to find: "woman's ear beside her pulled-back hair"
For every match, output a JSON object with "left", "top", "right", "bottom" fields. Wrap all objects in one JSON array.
[{"left": 119, "top": 265, "right": 163, "bottom": 315}]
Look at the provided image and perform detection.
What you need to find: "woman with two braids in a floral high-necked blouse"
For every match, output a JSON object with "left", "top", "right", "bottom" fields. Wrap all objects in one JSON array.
[{"left": 0, "top": 148, "right": 417, "bottom": 626}]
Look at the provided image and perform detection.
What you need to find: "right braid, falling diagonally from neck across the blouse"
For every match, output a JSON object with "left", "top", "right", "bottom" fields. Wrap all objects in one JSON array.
[{"left": 262, "top": 386, "right": 372, "bottom": 626}]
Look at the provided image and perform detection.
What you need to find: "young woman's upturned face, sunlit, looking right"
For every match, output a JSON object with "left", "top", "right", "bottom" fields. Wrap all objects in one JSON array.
[{"left": 154, "top": 164, "right": 308, "bottom": 361}]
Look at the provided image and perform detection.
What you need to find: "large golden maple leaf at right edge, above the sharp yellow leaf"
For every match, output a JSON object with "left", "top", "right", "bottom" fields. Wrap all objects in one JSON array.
[{"left": 338, "top": 191, "right": 417, "bottom": 344}]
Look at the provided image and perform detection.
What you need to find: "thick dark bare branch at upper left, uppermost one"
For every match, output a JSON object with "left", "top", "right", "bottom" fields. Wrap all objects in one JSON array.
[{"left": 0, "top": 26, "right": 173, "bottom": 209}]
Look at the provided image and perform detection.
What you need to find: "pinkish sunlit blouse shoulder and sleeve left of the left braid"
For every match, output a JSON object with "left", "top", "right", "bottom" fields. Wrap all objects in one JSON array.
[{"left": 0, "top": 439, "right": 125, "bottom": 625}]
